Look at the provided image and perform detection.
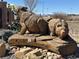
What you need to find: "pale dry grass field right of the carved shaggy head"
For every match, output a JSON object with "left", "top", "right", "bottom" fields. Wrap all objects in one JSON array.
[{"left": 67, "top": 21, "right": 79, "bottom": 43}]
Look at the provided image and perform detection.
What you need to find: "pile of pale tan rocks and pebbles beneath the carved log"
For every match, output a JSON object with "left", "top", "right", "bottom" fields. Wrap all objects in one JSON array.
[{"left": 11, "top": 47, "right": 64, "bottom": 59}]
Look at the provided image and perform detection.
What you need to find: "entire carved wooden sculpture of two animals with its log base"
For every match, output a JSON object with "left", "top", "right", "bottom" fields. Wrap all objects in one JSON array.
[{"left": 8, "top": 7, "right": 77, "bottom": 55}]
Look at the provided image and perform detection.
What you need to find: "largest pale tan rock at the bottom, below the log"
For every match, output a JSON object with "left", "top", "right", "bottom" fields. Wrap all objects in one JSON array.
[{"left": 15, "top": 48, "right": 42, "bottom": 59}]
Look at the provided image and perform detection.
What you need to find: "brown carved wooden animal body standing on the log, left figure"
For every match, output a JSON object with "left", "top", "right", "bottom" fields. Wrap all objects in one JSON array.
[{"left": 17, "top": 7, "right": 48, "bottom": 34}]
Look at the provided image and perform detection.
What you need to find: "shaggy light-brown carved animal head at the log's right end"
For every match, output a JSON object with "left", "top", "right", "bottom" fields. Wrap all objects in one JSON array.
[{"left": 48, "top": 19, "right": 69, "bottom": 38}]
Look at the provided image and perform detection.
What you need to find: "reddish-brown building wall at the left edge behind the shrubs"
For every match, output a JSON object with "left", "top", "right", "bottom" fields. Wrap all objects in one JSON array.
[{"left": 0, "top": 2, "right": 14, "bottom": 28}]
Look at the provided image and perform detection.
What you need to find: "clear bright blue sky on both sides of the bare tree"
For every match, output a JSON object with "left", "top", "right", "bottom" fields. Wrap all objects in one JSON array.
[{"left": 6, "top": 0, "right": 79, "bottom": 14}]
